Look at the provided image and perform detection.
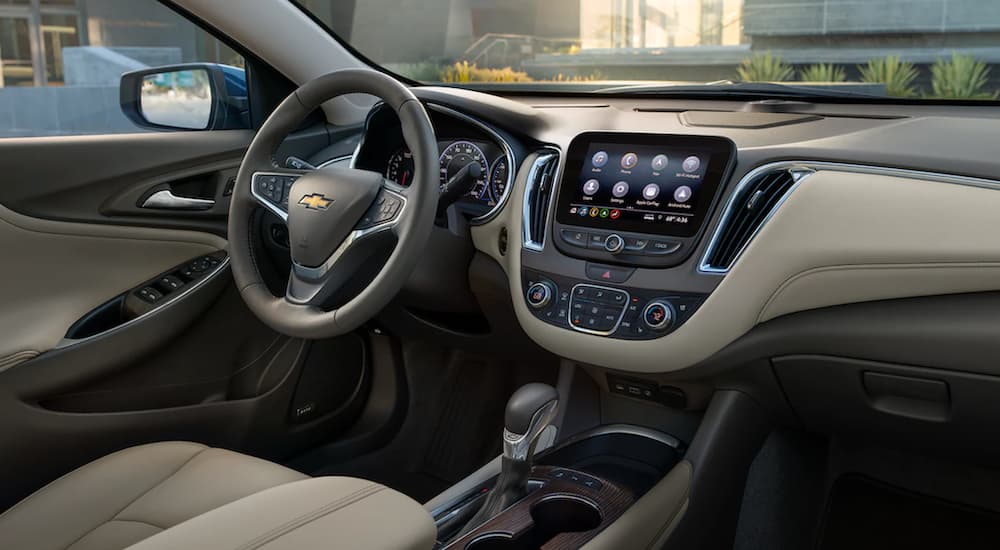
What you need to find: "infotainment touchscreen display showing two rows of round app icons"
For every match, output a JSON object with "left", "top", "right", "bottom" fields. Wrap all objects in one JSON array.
[{"left": 556, "top": 133, "right": 733, "bottom": 237}]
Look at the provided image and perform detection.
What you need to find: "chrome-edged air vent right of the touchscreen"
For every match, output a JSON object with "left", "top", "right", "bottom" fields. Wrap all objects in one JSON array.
[{"left": 701, "top": 170, "right": 810, "bottom": 273}]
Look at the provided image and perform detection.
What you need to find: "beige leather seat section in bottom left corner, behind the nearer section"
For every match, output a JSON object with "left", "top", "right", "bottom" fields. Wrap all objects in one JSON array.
[{"left": 0, "top": 442, "right": 307, "bottom": 550}]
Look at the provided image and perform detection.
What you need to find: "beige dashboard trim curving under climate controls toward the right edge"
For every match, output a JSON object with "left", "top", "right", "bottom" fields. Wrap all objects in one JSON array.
[{"left": 473, "top": 156, "right": 1000, "bottom": 373}]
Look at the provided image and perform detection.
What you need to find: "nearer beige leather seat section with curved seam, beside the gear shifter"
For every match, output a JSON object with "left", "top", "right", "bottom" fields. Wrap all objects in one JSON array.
[{"left": 130, "top": 477, "right": 437, "bottom": 550}]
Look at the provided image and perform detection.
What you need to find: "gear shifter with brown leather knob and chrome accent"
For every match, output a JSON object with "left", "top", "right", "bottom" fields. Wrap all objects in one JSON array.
[{"left": 459, "top": 384, "right": 559, "bottom": 536}]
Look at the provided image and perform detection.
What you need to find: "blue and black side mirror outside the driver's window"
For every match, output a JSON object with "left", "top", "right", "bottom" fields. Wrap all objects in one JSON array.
[{"left": 120, "top": 63, "right": 250, "bottom": 130}]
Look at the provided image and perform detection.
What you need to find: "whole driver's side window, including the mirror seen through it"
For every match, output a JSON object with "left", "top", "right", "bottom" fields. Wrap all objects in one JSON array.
[{"left": 0, "top": 0, "right": 249, "bottom": 138}]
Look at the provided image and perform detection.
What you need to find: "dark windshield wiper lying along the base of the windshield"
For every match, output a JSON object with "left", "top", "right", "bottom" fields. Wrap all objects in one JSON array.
[{"left": 593, "top": 80, "right": 886, "bottom": 99}]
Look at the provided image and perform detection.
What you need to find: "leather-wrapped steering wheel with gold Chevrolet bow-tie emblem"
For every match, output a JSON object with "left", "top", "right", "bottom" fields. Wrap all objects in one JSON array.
[{"left": 228, "top": 69, "right": 439, "bottom": 339}]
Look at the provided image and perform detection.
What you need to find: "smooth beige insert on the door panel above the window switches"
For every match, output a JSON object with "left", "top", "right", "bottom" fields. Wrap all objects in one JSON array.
[{"left": 0, "top": 206, "right": 227, "bottom": 369}]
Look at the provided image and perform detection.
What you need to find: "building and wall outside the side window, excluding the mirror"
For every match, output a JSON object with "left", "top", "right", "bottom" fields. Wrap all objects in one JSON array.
[{"left": 0, "top": 0, "right": 243, "bottom": 137}]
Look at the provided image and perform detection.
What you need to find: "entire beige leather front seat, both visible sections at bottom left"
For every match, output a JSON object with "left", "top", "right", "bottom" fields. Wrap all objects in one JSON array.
[{"left": 0, "top": 442, "right": 436, "bottom": 550}]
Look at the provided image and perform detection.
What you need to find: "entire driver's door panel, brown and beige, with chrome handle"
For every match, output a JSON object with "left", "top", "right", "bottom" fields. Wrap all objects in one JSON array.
[{"left": 0, "top": 126, "right": 371, "bottom": 510}]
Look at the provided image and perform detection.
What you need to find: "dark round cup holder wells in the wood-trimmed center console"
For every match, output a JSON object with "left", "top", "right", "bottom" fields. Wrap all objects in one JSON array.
[{"left": 465, "top": 495, "right": 601, "bottom": 550}]
